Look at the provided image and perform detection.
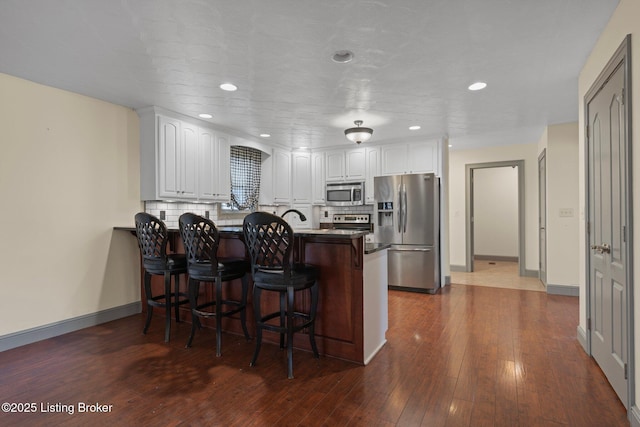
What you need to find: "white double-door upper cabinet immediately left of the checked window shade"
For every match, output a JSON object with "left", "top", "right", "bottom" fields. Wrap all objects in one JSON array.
[{"left": 198, "top": 129, "right": 231, "bottom": 203}]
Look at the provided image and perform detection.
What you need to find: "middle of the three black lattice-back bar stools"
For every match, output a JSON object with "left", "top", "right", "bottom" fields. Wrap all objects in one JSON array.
[{"left": 178, "top": 213, "right": 251, "bottom": 357}]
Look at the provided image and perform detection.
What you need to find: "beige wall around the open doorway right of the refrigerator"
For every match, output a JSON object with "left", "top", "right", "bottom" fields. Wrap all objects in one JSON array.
[{"left": 449, "top": 143, "right": 538, "bottom": 271}]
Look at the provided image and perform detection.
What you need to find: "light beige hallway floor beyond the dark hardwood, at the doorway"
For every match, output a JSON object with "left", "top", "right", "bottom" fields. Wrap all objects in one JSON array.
[{"left": 451, "top": 260, "right": 546, "bottom": 292}]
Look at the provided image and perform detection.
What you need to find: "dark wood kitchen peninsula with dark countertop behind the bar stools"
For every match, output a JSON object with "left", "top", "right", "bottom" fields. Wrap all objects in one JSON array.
[{"left": 116, "top": 227, "right": 388, "bottom": 365}]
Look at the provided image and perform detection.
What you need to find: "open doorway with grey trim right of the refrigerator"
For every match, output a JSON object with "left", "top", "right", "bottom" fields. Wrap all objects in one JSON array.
[{"left": 465, "top": 160, "right": 526, "bottom": 276}]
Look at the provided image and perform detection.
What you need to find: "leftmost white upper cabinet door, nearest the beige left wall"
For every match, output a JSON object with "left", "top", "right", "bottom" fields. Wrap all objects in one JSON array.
[{"left": 156, "top": 116, "right": 181, "bottom": 198}]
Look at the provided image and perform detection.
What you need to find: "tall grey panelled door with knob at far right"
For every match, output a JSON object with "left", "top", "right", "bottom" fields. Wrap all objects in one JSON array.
[{"left": 587, "top": 62, "right": 628, "bottom": 406}]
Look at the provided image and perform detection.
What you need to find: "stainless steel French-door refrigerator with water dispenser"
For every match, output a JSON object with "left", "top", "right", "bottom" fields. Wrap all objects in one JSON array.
[{"left": 373, "top": 173, "right": 440, "bottom": 293}]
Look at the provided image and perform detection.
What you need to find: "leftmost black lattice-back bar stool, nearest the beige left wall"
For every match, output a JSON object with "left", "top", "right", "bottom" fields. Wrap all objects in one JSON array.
[{"left": 135, "top": 212, "right": 189, "bottom": 342}]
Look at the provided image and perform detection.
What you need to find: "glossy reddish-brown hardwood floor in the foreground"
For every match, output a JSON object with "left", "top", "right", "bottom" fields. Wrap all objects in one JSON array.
[{"left": 0, "top": 285, "right": 629, "bottom": 427}]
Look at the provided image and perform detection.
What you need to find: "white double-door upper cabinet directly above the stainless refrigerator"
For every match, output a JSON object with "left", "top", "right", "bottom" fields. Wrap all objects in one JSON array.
[{"left": 381, "top": 141, "right": 439, "bottom": 175}]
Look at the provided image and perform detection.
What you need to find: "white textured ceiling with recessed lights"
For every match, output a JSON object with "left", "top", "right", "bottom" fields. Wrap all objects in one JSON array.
[{"left": 0, "top": 0, "right": 618, "bottom": 149}]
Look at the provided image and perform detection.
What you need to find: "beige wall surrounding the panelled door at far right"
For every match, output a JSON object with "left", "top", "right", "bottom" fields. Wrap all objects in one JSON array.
[{"left": 577, "top": 0, "right": 640, "bottom": 408}]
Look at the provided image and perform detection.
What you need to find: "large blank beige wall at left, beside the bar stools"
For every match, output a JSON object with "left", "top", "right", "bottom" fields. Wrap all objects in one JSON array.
[{"left": 0, "top": 74, "right": 142, "bottom": 336}]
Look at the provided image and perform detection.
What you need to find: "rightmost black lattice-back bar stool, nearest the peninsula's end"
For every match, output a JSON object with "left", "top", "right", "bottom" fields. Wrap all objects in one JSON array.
[{"left": 243, "top": 212, "right": 319, "bottom": 378}]
